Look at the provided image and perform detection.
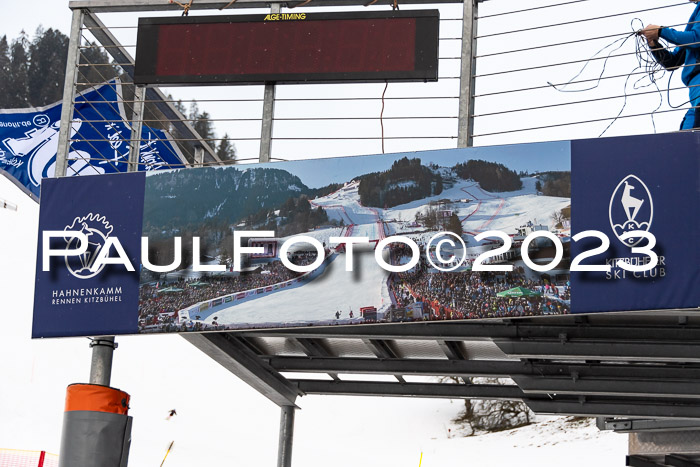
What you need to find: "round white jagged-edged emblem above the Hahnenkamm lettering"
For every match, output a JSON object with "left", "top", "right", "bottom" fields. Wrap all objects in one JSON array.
[{"left": 63, "top": 213, "right": 114, "bottom": 279}]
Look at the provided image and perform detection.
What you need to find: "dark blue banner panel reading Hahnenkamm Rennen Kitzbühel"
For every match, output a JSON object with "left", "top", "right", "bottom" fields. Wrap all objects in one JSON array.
[{"left": 32, "top": 173, "right": 146, "bottom": 337}]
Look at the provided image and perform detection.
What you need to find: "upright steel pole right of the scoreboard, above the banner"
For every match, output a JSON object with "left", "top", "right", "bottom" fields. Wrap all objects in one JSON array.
[{"left": 457, "top": 0, "right": 479, "bottom": 148}]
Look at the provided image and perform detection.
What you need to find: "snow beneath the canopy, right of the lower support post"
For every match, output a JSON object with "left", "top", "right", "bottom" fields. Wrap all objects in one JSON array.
[{"left": 293, "top": 396, "right": 627, "bottom": 467}]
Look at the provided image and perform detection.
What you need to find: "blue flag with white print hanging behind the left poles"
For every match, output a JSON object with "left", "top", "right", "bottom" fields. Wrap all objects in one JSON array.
[{"left": 0, "top": 82, "right": 184, "bottom": 200}]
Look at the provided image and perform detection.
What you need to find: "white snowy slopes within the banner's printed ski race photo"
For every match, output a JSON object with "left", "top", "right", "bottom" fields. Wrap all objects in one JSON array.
[{"left": 190, "top": 169, "right": 570, "bottom": 326}]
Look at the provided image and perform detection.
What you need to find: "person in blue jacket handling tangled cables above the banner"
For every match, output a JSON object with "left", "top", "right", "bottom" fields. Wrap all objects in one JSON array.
[{"left": 640, "top": 0, "right": 700, "bottom": 130}]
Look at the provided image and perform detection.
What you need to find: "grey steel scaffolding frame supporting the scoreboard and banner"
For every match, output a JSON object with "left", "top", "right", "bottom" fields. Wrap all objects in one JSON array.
[{"left": 56, "top": 0, "right": 700, "bottom": 467}]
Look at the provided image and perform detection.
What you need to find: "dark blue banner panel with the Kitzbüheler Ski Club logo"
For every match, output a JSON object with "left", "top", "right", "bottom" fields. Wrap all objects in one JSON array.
[{"left": 571, "top": 133, "right": 700, "bottom": 313}]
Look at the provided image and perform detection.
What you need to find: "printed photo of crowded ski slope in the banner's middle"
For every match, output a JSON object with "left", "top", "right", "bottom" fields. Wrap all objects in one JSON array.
[{"left": 139, "top": 143, "right": 571, "bottom": 332}]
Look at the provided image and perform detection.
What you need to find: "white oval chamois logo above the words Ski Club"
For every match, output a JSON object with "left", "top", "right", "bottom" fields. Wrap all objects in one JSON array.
[{"left": 608, "top": 174, "right": 654, "bottom": 247}]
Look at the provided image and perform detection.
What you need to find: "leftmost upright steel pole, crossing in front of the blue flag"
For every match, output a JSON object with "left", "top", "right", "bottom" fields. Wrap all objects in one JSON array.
[{"left": 54, "top": 9, "right": 83, "bottom": 177}]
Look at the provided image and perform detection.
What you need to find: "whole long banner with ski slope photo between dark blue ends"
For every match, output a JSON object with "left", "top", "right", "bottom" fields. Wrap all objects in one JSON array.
[{"left": 33, "top": 133, "right": 700, "bottom": 337}]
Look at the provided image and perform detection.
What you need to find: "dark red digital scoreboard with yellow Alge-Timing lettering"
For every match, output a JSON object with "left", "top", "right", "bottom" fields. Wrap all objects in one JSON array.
[{"left": 134, "top": 10, "right": 439, "bottom": 85}]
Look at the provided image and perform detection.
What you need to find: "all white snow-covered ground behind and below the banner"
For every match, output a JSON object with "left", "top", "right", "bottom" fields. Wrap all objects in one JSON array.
[{"left": 0, "top": 177, "right": 627, "bottom": 467}]
